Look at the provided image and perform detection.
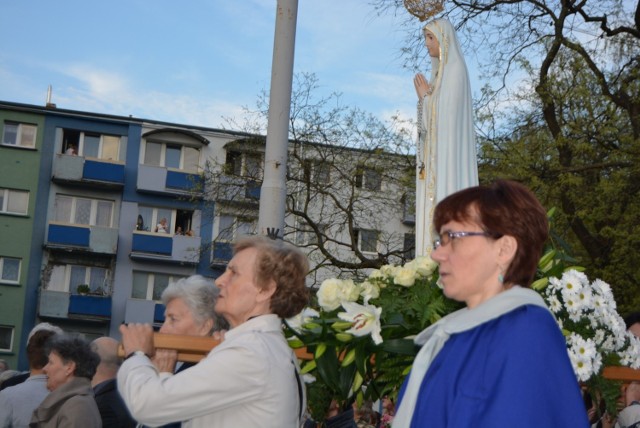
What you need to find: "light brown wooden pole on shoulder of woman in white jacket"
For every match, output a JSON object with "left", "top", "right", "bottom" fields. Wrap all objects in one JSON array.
[{"left": 118, "top": 333, "right": 313, "bottom": 363}]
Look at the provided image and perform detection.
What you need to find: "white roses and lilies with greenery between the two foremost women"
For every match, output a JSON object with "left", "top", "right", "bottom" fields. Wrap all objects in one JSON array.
[{"left": 287, "top": 257, "right": 460, "bottom": 421}]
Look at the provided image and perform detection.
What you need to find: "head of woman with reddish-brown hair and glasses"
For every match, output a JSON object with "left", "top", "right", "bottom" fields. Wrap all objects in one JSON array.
[{"left": 431, "top": 180, "right": 549, "bottom": 307}]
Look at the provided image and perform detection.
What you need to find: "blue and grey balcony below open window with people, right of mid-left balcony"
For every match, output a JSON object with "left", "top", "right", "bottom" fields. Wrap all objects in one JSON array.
[{"left": 130, "top": 231, "right": 201, "bottom": 265}]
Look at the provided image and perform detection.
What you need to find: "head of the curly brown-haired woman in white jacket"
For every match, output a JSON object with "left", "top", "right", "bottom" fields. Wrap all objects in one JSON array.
[{"left": 215, "top": 236, "right": 309, "bottom": 328}]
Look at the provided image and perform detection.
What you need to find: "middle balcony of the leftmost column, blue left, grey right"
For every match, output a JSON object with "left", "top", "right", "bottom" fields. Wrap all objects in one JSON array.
[{"left": 46, "top": 222, "right": 118, "bottom": 255}]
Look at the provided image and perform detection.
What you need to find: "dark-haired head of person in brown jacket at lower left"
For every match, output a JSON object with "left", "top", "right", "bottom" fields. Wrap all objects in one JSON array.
[{"left": 43, "top": 334, "right": 100, "bottom": 391}]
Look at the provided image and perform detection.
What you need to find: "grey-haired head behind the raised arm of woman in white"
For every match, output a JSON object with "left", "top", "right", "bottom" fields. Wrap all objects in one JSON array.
[{"left": 160, "top": 275, "right": 227, "bottom": 336}]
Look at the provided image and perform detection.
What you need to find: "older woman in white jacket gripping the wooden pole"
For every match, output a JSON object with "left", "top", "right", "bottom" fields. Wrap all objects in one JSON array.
[{"left": 118, "top": 237, "right": 308, "bottom": 428}]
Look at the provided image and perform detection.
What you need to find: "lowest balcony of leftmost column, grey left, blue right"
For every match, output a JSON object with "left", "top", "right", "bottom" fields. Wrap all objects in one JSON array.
[{"left": 39, "top": 290, "right": 111, "bottom": 322}]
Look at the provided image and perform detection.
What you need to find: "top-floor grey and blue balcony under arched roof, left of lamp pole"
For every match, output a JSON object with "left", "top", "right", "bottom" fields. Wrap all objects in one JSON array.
[{"left": 137, "top": 164, "right": 204, "bottom": 195}]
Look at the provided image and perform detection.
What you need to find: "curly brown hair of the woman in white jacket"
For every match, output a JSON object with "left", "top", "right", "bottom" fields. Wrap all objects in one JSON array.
[{"left": 233, "top": 236, "right": 309, "bottom": 318}]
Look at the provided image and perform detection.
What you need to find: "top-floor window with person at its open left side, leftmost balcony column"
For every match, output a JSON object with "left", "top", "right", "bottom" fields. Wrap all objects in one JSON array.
[{"left": 62, "top": 129, "right": 124, "bottom": 161}]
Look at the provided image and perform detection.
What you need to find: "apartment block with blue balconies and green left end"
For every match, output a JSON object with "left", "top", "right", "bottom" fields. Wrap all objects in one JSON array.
[{"left": 0, "top": 102, "right": 412, "bottom": 369}]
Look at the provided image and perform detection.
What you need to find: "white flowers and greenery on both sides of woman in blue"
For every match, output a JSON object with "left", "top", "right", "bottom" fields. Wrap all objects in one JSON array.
[{"left": 287, "top": 249, "right": 640, "bottom": 421}]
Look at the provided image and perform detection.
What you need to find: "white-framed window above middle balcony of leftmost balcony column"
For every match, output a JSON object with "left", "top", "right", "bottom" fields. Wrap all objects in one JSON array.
[{"left": 56, "top": 195, "right": 113, "bottom": 227}]
